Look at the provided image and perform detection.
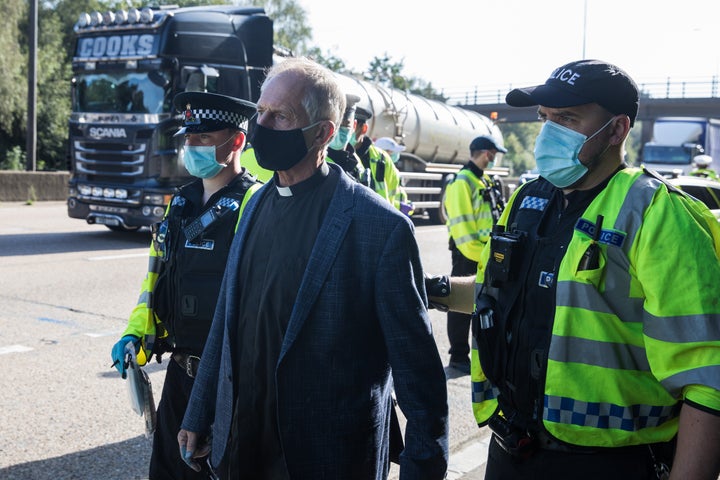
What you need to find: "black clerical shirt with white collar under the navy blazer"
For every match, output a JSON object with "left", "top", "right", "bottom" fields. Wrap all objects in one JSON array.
[{"left": 228, "top": 164, "right": 340, "bottom": 479}]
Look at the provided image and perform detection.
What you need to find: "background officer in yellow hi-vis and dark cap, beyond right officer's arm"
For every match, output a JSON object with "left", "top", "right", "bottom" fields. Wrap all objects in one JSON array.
[{"left": 443, "top": 135, "right": 507, "bottom": 375}]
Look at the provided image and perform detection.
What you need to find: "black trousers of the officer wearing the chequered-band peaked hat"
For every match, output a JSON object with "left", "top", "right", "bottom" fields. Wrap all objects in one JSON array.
[{"left": 150, "top": 357, "right": 208, "bottom": 480}]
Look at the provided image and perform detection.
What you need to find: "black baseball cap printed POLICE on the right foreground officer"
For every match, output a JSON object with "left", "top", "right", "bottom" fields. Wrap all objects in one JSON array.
[{"left": 505, "top": 60, "right": 639, "bottom": 126}]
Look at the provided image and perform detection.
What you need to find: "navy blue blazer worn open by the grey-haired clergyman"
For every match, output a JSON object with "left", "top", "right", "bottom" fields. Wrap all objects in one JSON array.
[{"left": 182, "top": 165, "right": 448, "bottom": 480}]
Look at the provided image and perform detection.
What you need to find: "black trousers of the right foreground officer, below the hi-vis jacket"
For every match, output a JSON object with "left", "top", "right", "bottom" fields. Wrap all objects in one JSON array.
[{"left": 485, "top": 436, "right": 656, "bottom": 480}]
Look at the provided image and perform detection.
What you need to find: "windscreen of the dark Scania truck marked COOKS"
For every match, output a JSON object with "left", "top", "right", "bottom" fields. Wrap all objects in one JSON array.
[{"left": 73, "top": 71, "right": 170, "bottom": 113}]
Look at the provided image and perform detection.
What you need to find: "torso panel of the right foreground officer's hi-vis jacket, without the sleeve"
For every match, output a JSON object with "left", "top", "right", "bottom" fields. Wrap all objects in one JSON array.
[{"left": 543, "top": 169, "right": 678, "bottom": 446}]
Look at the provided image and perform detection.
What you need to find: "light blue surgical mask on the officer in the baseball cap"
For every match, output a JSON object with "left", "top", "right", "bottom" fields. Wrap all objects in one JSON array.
[{"left": 535, "top": 117, "right": 614, "bottom": 188}]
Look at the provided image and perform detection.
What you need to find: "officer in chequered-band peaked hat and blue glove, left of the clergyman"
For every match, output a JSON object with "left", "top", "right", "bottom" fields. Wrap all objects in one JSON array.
[{"left": 112, "top": 92, "right": 255, "bottom": 480}]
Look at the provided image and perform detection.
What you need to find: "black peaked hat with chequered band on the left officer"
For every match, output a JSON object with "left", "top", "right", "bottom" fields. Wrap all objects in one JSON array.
[{"left": 173, "top": 92, "right": 257, "bottom": 135}]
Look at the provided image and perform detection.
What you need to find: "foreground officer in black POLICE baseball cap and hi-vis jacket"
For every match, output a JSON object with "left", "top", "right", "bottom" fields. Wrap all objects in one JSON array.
[{"left": 433, "top": 60, "right": 720, "bottom": 480}]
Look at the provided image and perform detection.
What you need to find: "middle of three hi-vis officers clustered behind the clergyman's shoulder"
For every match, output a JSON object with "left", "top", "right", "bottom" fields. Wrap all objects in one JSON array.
[{"left": 351, "top": 106, "right": 410, "bottom": 215}]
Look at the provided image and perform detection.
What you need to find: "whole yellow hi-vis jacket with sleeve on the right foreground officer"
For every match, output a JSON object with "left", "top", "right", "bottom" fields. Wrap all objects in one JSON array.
[{"left": 472, "top": 168, "right": 720, "bottom": 447}]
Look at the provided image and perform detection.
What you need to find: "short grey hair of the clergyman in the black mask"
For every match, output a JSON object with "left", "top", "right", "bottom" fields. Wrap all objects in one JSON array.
[{"left": 260, "top": 57, "right": 345, "bottom": 128}]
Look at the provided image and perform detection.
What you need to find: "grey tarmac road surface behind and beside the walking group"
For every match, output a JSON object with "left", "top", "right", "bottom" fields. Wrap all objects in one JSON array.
[{"left": 0, "top": 202, "right": 487, "bottom": 480}]
